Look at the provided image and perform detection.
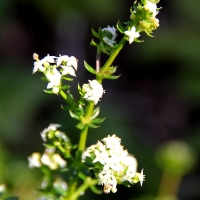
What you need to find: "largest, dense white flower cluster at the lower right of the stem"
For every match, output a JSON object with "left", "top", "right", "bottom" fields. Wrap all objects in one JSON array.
[{"left": 83, "top": 135, "right": 144, "bottom": 193}]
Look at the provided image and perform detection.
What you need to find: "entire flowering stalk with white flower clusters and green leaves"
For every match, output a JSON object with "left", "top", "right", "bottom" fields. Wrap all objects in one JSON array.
[{"left": 28, "top": 0, "right": 159, "bottom": 200}]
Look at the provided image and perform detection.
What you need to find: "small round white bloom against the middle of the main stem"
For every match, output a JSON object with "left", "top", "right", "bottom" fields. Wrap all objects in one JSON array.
[{"left": 83, "top": 80, "right": 104, "bottom": 104}]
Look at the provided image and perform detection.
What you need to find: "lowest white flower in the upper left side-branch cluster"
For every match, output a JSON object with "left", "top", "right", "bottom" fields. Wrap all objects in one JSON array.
[{"left": 45, "top": 68, "right": 61, "bottom": 94}]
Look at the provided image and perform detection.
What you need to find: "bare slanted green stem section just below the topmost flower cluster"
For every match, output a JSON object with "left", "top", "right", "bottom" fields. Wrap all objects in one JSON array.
[{"left": 100, "top": 37, "right": 127, "bottom": 74}]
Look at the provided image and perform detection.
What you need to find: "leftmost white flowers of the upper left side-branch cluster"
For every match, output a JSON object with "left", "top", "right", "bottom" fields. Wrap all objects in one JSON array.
[{"left": 33, "top": 55, "right": 56, "bottom": 74}]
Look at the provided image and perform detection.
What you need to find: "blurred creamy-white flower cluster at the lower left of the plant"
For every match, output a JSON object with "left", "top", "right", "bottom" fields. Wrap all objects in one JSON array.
[{"left": 28, "top": 148, "right": 67, "bottom": 170}]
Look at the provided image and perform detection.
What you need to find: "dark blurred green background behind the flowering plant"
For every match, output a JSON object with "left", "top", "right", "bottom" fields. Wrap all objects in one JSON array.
[{"left": 0, "top": 0, "right": 200, "bottom": 200}]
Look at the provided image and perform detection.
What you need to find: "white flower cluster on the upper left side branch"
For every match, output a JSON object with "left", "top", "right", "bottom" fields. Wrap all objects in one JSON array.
[{"left": 33, "top": 53, "right": 78, "bottom": 94}]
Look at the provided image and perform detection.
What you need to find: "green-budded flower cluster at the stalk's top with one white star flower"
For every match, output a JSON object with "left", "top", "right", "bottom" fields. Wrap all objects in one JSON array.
[{"left": 124, "top": 0, "right": 159, "bottom": 44}]
